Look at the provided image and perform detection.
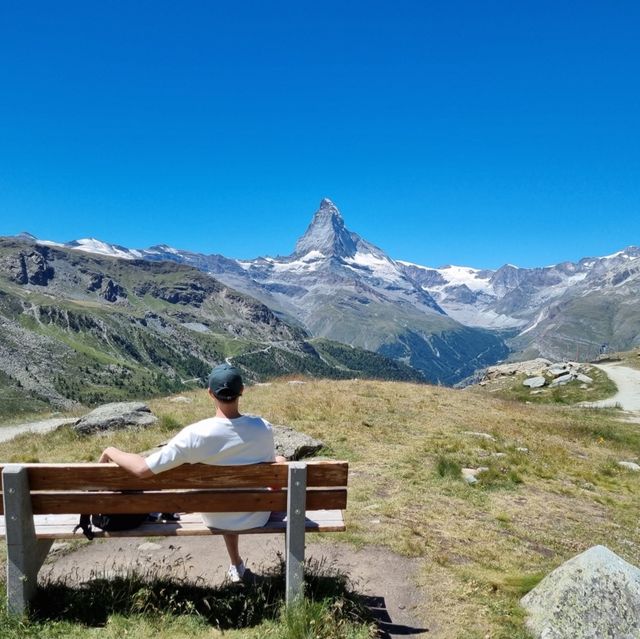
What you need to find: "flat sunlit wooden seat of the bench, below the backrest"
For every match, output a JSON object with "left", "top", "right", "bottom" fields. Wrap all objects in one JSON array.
[{"left": 0, "top": 510, "right": 345, "bottom": 539}]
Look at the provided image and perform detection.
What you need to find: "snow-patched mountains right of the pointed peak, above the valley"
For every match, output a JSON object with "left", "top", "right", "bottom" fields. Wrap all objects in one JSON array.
[{"left": 401, "top": 246, "right": 640, "bottom": 359}]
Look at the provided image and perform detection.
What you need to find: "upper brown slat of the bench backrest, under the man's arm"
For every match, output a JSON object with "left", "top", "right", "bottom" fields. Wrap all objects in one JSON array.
[{"left": 0, "top": 461, "right": 348, "bottom": 490}]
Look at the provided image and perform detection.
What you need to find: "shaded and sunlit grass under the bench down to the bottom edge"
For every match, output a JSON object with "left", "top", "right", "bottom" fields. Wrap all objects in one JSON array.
[{"left": 0, "top": 562, "right": 374, "bottom": 639}]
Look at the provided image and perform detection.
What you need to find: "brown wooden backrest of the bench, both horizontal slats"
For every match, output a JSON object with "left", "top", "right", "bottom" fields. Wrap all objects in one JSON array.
[{"left": 0, "top": 461, "right": 348, "bottom": 515}]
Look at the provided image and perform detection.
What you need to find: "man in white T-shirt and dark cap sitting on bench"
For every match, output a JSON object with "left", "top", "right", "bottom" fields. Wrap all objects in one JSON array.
[{"left": 100, "top": 364, "right": 286, "bottom": 582}]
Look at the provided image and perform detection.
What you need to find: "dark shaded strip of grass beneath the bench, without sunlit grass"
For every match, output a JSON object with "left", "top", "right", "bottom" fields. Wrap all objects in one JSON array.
[{"left": 30, "top": 563, "right": 374, "bottom": 631}]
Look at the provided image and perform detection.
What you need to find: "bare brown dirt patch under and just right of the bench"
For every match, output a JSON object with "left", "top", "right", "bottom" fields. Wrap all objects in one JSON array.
[{"left": 46, "top": 535, "right": 430, "bottom": 637}]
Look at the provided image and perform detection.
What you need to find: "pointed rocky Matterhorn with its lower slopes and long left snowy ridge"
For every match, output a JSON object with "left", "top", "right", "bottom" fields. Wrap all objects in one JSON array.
[{"left": 23, "top": 199, "right": 508, "bottom": 384}]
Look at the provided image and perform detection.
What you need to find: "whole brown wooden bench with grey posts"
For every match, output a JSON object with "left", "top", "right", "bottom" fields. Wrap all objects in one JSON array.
[{"left": 0, "top": 461, "right": 348, "bottom": 614}]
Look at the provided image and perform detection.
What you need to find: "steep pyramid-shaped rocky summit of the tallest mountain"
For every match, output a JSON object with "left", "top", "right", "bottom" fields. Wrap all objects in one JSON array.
[{"left": 294, "top": 198, "right": 359, "bottom": 257}]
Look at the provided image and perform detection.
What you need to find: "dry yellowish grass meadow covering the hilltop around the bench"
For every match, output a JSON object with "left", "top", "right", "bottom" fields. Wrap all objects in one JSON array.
[{"left": 0, "top": 381, "right": 640, "bottom": 639}]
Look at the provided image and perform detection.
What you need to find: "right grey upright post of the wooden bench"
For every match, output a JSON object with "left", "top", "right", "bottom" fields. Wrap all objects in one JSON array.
[{"left": 286, "top": 463, "right": 307, "bottom": 606}]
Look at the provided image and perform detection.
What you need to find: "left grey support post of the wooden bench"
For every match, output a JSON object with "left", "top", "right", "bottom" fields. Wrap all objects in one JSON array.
[{"left": 2, "top": 465, "right": 53, "bottom": 615}]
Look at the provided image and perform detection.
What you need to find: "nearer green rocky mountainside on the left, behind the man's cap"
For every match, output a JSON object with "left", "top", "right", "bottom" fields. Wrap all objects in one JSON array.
[{"left": 0, "top": 235, "right": 424, "bottom": 415}]
